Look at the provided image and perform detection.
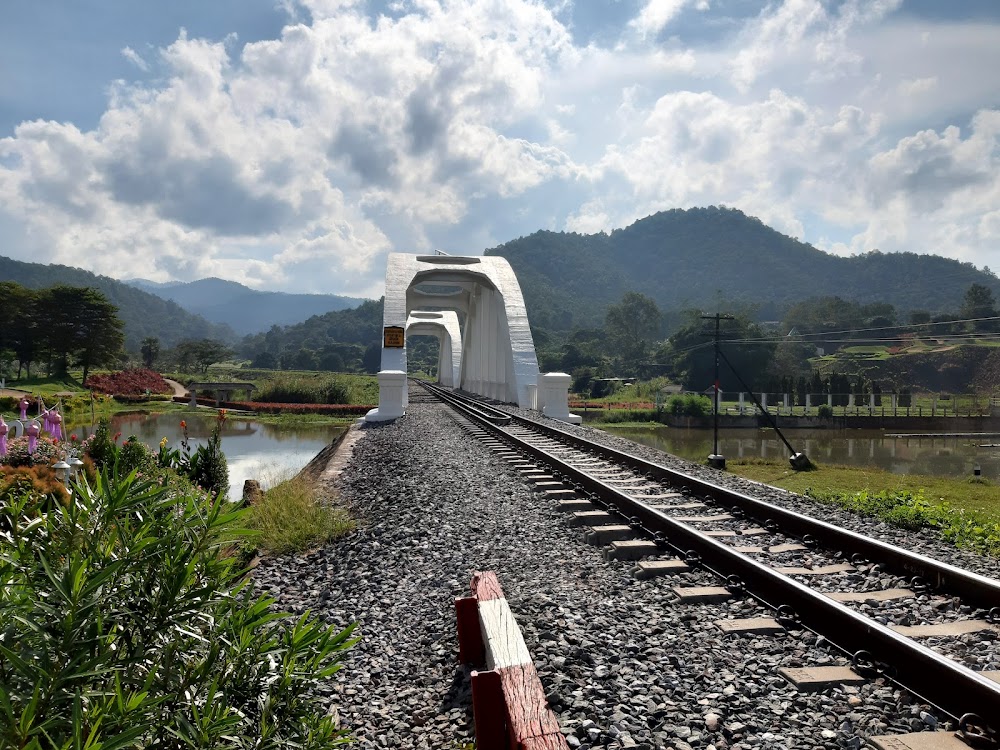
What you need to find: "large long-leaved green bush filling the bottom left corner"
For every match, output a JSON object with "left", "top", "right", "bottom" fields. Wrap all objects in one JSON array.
[{"left": 0, "top": 471, "right": 354, "bottom": 750}]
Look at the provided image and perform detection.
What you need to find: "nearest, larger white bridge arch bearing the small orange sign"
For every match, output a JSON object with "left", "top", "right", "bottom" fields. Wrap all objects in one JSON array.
[{"left": 366, "top": 253, "right": 538, "bottom": 421}]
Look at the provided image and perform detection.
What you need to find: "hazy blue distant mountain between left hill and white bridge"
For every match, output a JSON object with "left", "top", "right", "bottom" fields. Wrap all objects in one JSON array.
[{"left": 126, "top": 278, "right": 365, "bottom": 334}]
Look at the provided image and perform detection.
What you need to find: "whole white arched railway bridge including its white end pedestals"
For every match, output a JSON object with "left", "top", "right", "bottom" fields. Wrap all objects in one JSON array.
[{"left": 365, "top": 253, "right": 580, "bottom": 422}]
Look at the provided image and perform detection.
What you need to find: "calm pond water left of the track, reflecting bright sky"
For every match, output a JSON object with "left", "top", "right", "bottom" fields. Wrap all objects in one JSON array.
[{"left": 70, "top": 413, "right": 344, "bottom": 499}]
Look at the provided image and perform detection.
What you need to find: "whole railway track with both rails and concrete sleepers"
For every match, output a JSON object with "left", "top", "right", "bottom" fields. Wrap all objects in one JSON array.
[{"left": 420, "top": 383, "right": 1000, "bottom": 748}]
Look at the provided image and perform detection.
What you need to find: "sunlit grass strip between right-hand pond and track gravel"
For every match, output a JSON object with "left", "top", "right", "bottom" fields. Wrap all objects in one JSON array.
[{"left": 726, "top": 459, "right": 1000, "bottom": 523}]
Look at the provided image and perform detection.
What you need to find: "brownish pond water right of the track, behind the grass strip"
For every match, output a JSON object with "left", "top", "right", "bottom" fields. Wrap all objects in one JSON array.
[{"left": 605, "top": 425, "right": 1000, "bottom": 479}]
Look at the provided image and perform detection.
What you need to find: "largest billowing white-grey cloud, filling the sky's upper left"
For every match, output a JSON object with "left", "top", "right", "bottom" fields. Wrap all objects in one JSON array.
[{"left": 0, "top": 0, "right": 573, "bottom": 291}]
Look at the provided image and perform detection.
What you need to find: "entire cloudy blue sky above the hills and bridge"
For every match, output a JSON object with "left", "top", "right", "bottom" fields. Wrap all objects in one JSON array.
[{"left": 0, "top": 0, "right": 1000, "bottom": 296}]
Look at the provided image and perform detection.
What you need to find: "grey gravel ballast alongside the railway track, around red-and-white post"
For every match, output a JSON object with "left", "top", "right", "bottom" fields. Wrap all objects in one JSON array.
[{"left": 254, "top": 392, "right": 998, "bottom": 750}]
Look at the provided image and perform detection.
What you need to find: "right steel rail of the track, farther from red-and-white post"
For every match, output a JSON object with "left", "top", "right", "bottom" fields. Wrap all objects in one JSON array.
[{"left": 420, "top": 388, "right": 1000, "bottom": 610}]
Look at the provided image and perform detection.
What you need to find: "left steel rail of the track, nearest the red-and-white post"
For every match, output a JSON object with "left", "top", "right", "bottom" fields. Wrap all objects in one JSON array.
[{"left": 416, "top": 384, "right": 1000, "bottom": 721}]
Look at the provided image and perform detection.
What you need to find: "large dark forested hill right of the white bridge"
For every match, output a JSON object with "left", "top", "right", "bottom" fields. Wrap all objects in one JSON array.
[{"left": 486, "top": 206, "right": 1000, "bottom": 330}]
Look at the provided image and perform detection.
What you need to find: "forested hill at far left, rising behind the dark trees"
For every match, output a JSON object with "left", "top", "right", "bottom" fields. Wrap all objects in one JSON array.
[{"left": 0, "top": 256, "right": 236, "bottom": 351}]
